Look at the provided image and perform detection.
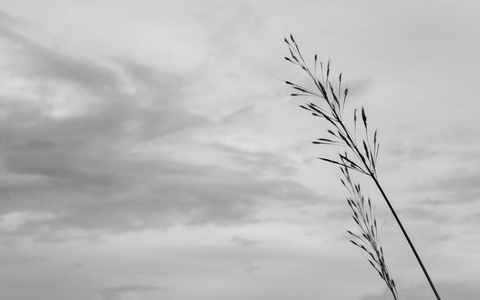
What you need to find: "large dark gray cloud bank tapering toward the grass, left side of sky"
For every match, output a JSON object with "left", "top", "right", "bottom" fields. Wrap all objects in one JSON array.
[{"left": 0, "top": 12, "right": 315, "bottom": 238}]
